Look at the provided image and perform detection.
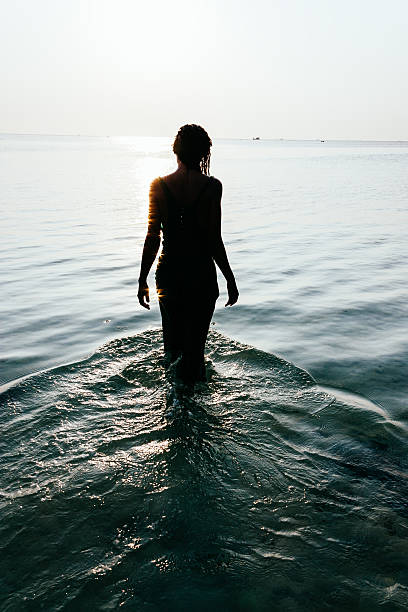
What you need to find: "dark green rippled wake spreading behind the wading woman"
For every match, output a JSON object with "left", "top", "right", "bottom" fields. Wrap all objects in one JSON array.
[{"left": 0, "top": 330, "right": 408, "bottom": 612}]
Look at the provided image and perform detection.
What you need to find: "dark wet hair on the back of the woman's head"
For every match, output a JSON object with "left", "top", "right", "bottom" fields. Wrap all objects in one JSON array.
[{"left": 173, "top": 123, "right": 212, "bottom": 175}]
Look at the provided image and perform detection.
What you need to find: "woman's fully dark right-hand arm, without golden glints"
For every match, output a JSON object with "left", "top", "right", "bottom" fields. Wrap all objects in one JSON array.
[{"left": 210, "top": 179, "right": 239, "bottom": 306}]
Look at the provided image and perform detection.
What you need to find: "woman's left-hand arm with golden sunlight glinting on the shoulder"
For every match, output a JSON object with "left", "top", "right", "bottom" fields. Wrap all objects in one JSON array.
[{"left": 137, "top": 179, "right": 161, "bottom": 310}]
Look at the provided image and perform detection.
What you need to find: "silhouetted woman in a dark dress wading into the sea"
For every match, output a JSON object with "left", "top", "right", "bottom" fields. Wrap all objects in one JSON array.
[{"left": 138, "top": 125, "right": 238, "bottom": 383}]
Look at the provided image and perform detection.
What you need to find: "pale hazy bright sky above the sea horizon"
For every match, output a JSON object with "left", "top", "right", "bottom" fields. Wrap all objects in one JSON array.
[{"left": 0, "top": 0, "right": 408, "bottom": 140}]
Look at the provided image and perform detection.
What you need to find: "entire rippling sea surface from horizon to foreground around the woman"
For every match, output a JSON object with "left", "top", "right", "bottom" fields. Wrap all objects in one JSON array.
[{"left": 0, "top": 135, "right": 408, "bottom": 612}]
